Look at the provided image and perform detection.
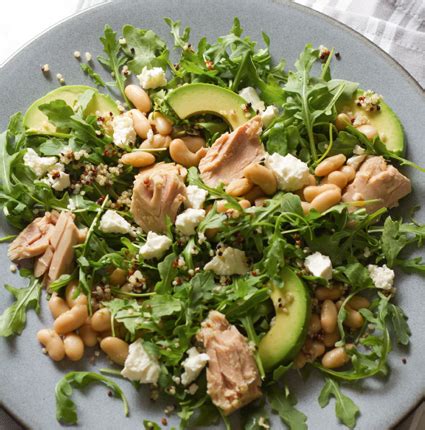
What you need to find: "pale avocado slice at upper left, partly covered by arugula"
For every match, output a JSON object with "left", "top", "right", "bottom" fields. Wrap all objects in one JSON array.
[{"left": 23, "top": 85, "right": 119, "bottom": 133}]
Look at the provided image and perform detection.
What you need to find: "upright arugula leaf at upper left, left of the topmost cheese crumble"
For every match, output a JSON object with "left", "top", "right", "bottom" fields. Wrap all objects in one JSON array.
[{"left": 97, "top": 25, "right": 127, "bottom": 106}]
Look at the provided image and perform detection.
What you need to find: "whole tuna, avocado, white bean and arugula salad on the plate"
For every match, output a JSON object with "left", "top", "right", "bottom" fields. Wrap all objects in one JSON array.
[{"left": 0, "top": 19, "right": 425, "bottom": 429}]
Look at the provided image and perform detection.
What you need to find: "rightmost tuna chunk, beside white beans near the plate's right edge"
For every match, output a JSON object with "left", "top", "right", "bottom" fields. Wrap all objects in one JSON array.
[{"left": 342, "top": 156, "right": 412, "bottom": 212}]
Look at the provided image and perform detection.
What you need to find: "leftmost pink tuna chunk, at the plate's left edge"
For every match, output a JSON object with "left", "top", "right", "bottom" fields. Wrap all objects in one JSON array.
[{"left": 7, "top": 212, "right": 56, "bottom": 261}]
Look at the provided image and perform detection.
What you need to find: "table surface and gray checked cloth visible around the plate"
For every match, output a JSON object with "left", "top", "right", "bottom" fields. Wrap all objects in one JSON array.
[{"left": 0, "top": 0, "right": 425, "bottom": 430}]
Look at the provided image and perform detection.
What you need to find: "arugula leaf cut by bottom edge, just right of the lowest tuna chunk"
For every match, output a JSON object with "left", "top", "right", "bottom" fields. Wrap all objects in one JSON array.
[{"left": 267, "top": 385, "right": 307, "bottom": 430}]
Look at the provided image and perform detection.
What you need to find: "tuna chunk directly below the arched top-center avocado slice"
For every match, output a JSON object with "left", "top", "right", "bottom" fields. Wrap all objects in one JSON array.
[{"left": 199, "top": 116, "right": 264, "bottom": 187}]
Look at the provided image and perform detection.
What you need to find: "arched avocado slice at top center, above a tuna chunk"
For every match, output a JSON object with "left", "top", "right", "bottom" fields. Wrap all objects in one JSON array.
[{"left": 167, "top": 83, "right": 252, "bottom": 129}]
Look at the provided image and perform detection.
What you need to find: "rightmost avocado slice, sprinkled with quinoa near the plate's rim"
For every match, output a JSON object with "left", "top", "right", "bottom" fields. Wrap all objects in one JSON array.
[{"left": 340, "top": 90, "right": 405, "bottom": 155}]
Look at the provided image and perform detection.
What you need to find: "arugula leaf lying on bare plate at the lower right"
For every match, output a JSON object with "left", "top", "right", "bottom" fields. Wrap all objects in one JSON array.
[{"left": 319, "top": 378, "right": 360, "bottom": 428}]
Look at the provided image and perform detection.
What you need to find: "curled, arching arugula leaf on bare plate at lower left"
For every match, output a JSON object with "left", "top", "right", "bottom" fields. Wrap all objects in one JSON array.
[{"left": 55, "top": 371, "right": 128, "bottom": 424}]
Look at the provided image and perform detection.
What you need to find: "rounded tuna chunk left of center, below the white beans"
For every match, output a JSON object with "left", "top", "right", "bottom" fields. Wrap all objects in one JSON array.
[{"left": 130, "top": 163, "right": 186, "bottom": 233}]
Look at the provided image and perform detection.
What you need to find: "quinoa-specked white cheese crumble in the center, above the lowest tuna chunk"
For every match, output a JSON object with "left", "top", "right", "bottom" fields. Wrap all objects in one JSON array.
[{"left": 204, "top": 246, "right": 249, "bottom": 276}]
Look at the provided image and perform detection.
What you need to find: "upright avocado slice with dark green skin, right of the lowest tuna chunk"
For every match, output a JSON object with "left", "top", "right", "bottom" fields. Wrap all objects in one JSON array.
[{"left": 258, "top": 267, "right": 311, "bottom": 371}]
